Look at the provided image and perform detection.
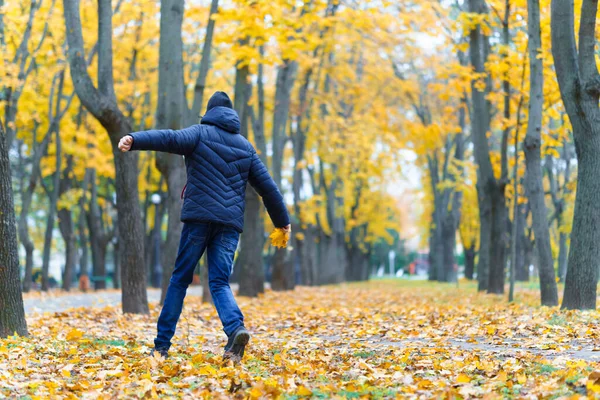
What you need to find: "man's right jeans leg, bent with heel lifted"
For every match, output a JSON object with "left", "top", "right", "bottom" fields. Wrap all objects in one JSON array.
[{"left": 206, "top": 226, "right": 244, "bottom": 336}]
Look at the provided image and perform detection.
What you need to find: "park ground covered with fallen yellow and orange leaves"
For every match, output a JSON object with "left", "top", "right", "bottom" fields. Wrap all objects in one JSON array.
[{"left": 0, "top": 281, "right": 600, "bottom": 399}]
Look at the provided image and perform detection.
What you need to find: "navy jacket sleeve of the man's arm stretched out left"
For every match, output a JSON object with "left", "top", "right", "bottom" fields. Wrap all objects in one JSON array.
[{"left": 131, "top": 125, "right": 200, "bottom": 156}]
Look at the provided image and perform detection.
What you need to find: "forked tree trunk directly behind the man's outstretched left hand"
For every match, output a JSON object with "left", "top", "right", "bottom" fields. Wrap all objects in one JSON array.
[{"left": 63, "top": 0, "right": 149, "bottom": 314}]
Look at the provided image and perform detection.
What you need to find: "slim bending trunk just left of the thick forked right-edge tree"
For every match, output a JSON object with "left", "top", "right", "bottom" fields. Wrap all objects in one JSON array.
[{"left": 524, "top": 0, "right": 558, "bottom": 306}]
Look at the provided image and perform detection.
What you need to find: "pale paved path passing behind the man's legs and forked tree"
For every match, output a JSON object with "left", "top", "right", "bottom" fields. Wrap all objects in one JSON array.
[{"left": 24, "top": 285, "right": 207, "bottom": 314}]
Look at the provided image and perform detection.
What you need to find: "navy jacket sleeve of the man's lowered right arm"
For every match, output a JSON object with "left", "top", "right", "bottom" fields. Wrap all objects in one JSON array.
[{"left": 248, "top": 152, "right": 290, "bottom": 228}]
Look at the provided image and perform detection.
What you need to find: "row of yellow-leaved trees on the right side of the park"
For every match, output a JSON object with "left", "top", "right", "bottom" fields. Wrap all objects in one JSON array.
[{"left": 414, "top": 0, "right": 599, "bottom": 309}]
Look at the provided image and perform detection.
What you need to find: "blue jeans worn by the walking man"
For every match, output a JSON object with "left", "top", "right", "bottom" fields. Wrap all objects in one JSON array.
[{"left": 154, "top": 223, "right": 244, "bottom": 350}]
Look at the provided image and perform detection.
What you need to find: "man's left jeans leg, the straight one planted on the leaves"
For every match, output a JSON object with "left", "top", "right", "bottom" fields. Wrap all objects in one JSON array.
[{"left": 154, "top": 223, "right": 210, "bottom": 350}]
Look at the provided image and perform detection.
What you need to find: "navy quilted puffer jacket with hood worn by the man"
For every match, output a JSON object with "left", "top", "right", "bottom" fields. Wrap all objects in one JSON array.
[{"left": 131, "top": 107, "right": 290, "bottom": 232}]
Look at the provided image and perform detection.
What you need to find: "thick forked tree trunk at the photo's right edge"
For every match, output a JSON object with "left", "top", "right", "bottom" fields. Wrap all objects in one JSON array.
[{"left": 551, "top": 0, "right": 600, "bottom": 309}]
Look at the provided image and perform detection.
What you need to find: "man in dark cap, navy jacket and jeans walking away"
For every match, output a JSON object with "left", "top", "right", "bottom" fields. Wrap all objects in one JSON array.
[{"left": 119, "top": 92, "right": 290, "bottom": 360}]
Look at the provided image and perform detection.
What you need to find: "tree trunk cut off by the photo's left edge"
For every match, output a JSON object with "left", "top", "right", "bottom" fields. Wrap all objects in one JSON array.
[{"left": 0, "top": 120, "right": 27, "bottom": 338}]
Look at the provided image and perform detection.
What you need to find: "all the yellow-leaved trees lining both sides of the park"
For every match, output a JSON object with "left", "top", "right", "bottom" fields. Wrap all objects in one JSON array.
[{"left": 0, "top": 0, "right": 600, "bottom": 334}]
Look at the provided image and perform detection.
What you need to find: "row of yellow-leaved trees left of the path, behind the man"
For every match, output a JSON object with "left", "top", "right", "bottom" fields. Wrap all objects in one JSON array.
[{"left": 1, "top": 0, "right": 398, "bottom": 336}]
